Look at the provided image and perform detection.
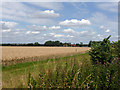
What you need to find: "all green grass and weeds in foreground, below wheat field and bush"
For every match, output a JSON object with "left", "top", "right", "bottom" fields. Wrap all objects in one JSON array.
[{"left": 2, "top": 53, "right": 119, "bottom": 89}]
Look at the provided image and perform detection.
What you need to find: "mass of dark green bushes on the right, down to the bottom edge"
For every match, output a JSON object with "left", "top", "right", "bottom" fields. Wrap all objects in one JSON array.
[{"left": 89, "top": 36, "right": 120, "bottom": 89}]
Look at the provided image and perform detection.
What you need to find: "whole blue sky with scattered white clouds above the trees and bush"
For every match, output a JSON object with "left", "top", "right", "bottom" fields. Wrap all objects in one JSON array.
[{"left": 0, "top": 2, "right": 118, "bottom": 44}]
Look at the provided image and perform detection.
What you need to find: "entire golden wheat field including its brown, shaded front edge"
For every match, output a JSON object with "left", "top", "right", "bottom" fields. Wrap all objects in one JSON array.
[{"left": 2, "top": 46, "right": 90, "bottom": 65}]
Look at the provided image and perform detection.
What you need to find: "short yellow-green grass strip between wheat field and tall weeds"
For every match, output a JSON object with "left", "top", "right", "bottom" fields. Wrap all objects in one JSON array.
[{"left": 2, "top": 53, "right": 90, "bottom": 88}]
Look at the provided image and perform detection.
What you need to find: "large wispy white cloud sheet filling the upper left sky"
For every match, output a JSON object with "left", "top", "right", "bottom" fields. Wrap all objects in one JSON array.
[{"left": 1, "top": 2, "right": 59, "bottom": 25}]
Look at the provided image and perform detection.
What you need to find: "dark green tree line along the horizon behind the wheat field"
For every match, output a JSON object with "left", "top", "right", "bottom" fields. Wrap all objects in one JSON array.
[{"left": 0, "top": 41, "right": 106, "bottom": 47}]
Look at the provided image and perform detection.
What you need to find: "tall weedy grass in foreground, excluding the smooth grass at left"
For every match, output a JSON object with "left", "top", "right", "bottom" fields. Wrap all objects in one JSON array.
[{"left": 28, "top": 52, "right": 118, "bottom": 89}]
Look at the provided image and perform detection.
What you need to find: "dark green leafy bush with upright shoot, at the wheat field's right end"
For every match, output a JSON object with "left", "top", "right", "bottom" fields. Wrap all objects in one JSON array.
[{"left": 89, "top": 36, "right": 113, "bottom": 64}]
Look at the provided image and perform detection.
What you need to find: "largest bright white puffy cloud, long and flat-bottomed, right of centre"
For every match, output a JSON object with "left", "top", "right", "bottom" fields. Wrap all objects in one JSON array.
[{"left": 59, "top": 19, "right": 91, "bottom": 27}]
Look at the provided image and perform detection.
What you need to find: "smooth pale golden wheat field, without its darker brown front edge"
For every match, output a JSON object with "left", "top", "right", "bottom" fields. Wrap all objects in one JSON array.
[{"left": 2, "top": 46, "right": 90, "bottom": 60}]
